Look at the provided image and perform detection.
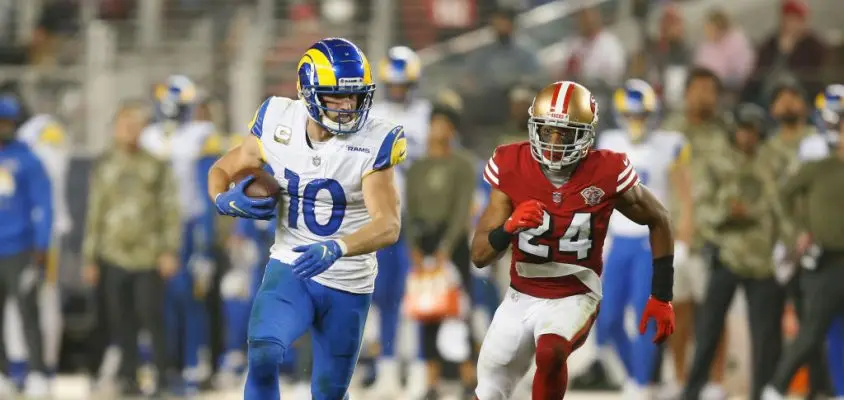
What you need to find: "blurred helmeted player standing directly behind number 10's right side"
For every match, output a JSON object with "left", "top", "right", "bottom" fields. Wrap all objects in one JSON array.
[{"left": 372, "top": 46, "right": 432, "bottom": 398}]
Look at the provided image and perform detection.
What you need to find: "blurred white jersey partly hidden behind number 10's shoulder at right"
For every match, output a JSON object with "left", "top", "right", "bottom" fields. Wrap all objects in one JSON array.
[{"left": 369, "top": 99, "right": 432, "bottom": 207}]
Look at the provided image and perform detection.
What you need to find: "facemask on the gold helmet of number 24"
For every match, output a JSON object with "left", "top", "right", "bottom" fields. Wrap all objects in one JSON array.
[{"left": 528, "top": 117, "right": 595, "bottom": 171}]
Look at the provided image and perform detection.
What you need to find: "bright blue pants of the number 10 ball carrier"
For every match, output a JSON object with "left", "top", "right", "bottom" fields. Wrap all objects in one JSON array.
[{"left": 244, "top": 260, "right": 372, "bottom": 400}]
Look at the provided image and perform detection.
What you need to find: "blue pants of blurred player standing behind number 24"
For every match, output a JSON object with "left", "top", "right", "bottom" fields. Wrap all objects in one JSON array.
[{"left": 596, "top": 236, "right": 657, "bottom": 386}]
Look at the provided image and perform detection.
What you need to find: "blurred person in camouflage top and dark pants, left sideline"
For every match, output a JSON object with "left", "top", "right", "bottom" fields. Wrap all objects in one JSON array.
[{"left": 82, "top": 102, "right": 181, "bottom": 395}]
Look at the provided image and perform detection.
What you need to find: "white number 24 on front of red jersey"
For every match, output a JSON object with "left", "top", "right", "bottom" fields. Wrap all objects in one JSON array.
[{"left": 519, "top": 212, "right": 592, "bottom": 260}]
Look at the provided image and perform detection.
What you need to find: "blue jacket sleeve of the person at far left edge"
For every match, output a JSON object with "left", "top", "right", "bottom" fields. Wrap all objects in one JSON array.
[{"left": 27, "top": 162, "right": 53, "bottom": 251}]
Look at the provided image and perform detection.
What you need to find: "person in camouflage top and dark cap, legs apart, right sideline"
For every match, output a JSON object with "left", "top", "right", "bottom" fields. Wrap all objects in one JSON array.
[{"left": 683, "top": 104, "right": 785, "bottom": 399}]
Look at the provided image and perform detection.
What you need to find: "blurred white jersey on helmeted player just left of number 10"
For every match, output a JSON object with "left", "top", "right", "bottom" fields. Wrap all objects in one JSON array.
[{"left": 140, "top": 121, "right": 222, "bottom": 221}]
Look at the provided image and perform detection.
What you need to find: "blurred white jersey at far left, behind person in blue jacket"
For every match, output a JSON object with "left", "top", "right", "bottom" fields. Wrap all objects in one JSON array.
[{"left": 17, "top": 114, "right": 73, "bottom": 236}]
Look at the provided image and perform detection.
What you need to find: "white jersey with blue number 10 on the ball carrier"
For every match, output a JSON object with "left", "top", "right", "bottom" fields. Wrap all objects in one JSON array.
[{"left": 250, "top": 97, "right": 407, "bottom": 293}]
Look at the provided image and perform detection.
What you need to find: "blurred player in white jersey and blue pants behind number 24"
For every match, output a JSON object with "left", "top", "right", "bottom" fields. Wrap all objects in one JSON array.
[{"left": 596, "top": 79, "right": 692, "bottom": 398}]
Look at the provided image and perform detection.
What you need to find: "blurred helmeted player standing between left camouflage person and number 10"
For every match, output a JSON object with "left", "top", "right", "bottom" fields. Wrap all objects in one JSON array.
[{"left": 140, "top": 75, "right": 222, "bottom": 392}]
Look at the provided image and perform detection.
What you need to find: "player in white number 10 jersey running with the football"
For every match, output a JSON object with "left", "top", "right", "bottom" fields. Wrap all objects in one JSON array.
[{"left": 208, "top": 38, "right": 407, "bottom": 400}]
